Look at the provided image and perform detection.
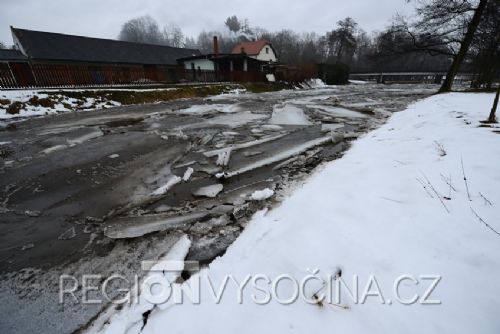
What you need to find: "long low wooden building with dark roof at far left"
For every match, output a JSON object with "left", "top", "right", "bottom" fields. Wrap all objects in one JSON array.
[{"left": 0, "top": 27, "right": 200, "bottom": 88}]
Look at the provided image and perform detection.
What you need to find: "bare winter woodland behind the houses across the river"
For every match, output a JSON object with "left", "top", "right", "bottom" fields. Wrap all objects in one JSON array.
[{"left": 118, "top": 0, "right": 500, "bottom": 73}]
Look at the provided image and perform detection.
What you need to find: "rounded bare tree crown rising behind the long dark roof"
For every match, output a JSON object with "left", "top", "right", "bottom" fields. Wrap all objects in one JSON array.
[{"left": 118, "top": 16, "right": 165, "bottom": 44}]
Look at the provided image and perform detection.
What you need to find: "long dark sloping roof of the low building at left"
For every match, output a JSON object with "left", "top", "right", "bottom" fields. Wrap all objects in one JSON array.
[{"left": 11, "top": 28, "right": 200, "bottom": 65}]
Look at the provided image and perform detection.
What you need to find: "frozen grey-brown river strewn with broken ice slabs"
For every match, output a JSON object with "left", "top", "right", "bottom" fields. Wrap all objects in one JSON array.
[{"left": 0, "top": 84, "right": 436, "bottom": 331}]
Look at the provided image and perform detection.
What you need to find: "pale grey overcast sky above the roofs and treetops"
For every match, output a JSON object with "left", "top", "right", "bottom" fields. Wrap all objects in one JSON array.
[{"left": 0, "top": 0, "right": 412, "bottom": 45}]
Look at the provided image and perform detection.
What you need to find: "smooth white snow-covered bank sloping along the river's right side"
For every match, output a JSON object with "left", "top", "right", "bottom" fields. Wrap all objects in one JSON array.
[{"left": 94, "top": 93, "right": 500, "bottom": 333}]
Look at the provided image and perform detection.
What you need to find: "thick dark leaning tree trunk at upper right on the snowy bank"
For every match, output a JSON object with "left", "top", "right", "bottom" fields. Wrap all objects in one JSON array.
[{"left": 439, "top": 0, "right": 488, "bottom": 93}]
